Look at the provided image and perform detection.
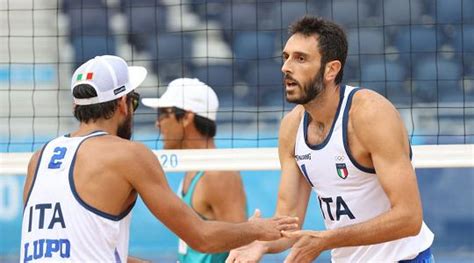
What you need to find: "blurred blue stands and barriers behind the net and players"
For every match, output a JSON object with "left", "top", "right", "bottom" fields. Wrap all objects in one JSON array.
[{"left": 0, "top": 0, "right": 474, "bottom": 262}]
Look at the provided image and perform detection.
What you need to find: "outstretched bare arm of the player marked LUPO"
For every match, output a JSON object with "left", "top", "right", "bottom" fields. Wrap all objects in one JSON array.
[{"left": 122, "top": 143, "right": 298, "bottom": 253}]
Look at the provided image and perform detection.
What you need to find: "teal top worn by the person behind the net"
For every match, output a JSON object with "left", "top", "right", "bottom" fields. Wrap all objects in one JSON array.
[{"left": 178, "top": 172, "right": 229, "bottom": 263}]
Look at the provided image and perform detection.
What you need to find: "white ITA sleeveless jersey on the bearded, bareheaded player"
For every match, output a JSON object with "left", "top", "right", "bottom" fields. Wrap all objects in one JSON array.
[{"left": 295, "top": 86, "right": 434, "bottom": 262}]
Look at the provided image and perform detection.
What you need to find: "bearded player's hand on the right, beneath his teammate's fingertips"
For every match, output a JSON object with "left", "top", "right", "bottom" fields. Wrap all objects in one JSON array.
[{"left": 282, "top": 230, "right": 324, "bottom": 263}]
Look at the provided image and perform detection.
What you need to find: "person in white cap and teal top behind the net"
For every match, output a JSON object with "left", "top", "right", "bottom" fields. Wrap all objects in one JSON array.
[{"left": 142, "top": 78, "right": 247, "bottom": 263}]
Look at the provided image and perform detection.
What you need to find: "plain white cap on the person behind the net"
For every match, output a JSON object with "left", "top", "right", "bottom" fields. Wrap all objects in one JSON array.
[{"left": 142, "top": 78, "right": 219, "bottom": 121}]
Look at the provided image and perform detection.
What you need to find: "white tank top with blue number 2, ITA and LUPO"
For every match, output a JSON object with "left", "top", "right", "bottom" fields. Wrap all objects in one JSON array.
[{"left": 20, "top": 131, "right": 133, "bottom": 262}]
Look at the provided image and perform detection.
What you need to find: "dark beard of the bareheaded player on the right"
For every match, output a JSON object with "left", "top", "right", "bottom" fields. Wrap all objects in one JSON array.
[{"left": 285, "top": 67, "right": 325, "bottom": 104}]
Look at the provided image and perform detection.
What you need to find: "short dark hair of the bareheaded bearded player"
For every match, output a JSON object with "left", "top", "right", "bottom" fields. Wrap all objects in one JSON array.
[{"left": 289, "top": 16, "right": 347, "bottom": 84}]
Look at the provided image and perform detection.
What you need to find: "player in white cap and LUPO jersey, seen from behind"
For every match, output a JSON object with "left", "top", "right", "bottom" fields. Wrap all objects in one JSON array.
[{"left": 20, "top": 56, "right": 297, "bottom": 262}]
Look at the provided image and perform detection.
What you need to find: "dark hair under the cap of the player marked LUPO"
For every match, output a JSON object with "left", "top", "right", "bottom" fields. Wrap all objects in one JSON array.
[{"left": 72, "top": 84, "right": 131, "bottom": 123}]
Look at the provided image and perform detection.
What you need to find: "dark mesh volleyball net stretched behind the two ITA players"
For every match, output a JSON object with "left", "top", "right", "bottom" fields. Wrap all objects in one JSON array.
[{"left": 0, "top": 0, "right": 474, "bottom": 174}]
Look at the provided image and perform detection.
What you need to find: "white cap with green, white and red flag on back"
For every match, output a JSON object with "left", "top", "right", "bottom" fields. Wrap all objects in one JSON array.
[{"left": 71, "top": 55, "right": 147, "bottom": 105}]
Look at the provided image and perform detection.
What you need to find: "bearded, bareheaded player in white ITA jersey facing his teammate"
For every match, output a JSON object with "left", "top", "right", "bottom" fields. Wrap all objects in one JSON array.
[{"left": 227, "top": 16, "right": 433, "bottom": 263}]
